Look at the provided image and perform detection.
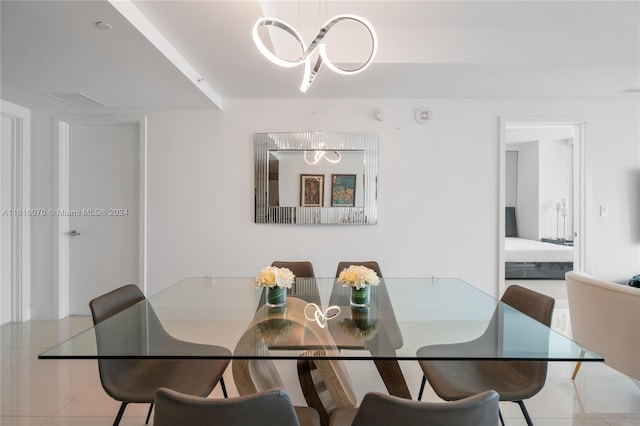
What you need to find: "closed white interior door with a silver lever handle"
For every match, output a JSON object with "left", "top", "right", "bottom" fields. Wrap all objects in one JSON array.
[{"left": 67, "top": 124, "right": 140, "bottom": 315}]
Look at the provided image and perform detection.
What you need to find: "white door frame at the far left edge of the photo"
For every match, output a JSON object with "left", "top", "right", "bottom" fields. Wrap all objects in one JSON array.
[{"left": 0, "top": 101, "right": 31, "bottom": 322}]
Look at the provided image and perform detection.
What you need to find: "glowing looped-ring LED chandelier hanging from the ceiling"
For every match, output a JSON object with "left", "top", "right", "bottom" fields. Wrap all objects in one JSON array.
[{"left": 252, "top": 15, "right": 378, "bottom": 93}]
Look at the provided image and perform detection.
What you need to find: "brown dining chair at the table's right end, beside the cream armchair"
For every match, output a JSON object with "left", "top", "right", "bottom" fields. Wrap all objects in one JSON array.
[{"left": 418, "top": 285, "right": 555, "bottom": 425}]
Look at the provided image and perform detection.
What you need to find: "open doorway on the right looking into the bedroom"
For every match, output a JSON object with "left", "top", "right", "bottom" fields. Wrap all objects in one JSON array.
[{"left": 498, "top": 118, "right": 585, "bottom": 293}]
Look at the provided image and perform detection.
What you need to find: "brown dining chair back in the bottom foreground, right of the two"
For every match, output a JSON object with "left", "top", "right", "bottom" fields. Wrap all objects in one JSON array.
[{"left": 330, "top": 390, "right": 499, "bottom": 426}]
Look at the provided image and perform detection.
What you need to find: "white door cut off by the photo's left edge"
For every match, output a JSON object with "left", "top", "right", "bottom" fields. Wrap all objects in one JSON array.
[{"left": 0, "top": 116, "right": 13, "bottom": 324}]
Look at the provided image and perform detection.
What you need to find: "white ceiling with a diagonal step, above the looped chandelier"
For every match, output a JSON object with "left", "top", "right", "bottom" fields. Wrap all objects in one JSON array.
[{"left": 0, "top": 0, "right": 640, "bottom": 109}]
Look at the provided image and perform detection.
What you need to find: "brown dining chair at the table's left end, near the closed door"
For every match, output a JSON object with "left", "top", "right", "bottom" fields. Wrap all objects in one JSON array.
[{"left": 89, "top": 284, "right": 231, "bottom": 426}]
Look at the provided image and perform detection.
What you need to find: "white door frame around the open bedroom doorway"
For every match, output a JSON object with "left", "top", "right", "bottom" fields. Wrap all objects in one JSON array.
[{"left": 496, "top": 116, "right": 589, "bottom": 295}]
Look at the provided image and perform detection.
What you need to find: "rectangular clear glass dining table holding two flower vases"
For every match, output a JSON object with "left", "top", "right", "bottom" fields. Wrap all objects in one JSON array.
[{"left": 38, "top": 277, "right": 604, "bottom": 398}]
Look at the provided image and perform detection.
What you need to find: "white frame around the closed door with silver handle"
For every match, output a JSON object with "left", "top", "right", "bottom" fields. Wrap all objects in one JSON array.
[{"left": 53, "top": 115, "right": 147, "bottom": 318}]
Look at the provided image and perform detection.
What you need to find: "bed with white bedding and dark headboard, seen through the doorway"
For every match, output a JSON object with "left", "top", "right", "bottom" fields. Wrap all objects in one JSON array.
[{"left": 504, "top": 207, "right": 573, "bottom": 280}]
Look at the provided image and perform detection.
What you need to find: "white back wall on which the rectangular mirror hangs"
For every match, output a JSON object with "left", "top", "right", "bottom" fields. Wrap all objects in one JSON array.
[{"left": 25, "top": 99, "right": 640, "bottom": 317}]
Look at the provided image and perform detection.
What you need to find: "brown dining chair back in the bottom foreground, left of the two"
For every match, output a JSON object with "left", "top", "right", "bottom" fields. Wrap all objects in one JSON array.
[{"left": 153, "top": 388, "right": 320, "bottom": 426}]
